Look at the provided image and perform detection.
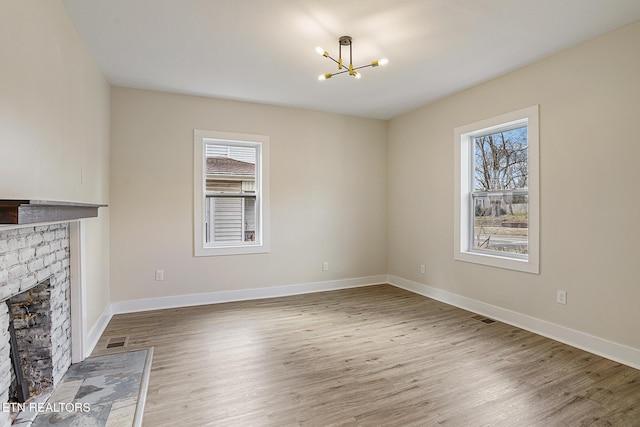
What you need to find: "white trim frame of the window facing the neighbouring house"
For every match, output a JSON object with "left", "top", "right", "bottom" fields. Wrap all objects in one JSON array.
[{"left": 193, "top": 129, "right": 270, "bottom": 256}]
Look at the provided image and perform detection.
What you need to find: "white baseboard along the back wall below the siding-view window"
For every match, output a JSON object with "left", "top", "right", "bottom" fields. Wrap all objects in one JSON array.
[{"left": 111, "top": 275, "right": 387, "bottom": 314}]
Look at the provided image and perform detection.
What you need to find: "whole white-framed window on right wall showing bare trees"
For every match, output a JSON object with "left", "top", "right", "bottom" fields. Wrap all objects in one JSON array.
[{"left": 454, "top": 105, "right": 539, "bottom": 273}]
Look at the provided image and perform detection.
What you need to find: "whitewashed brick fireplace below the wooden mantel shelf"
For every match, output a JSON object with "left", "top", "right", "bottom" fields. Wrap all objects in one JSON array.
[{"left": 0, "top": 223, "right": 71, "bottom": 425}]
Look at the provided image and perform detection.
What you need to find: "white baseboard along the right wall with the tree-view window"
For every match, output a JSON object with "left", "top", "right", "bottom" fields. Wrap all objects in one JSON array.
[{"left": 387, "top": 276, "right": 640, "bottom": 369}]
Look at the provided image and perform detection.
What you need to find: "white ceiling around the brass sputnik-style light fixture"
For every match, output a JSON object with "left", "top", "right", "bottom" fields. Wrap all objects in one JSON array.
[{"left": 63, "top": 0, "right": 640, "bottom": 119}]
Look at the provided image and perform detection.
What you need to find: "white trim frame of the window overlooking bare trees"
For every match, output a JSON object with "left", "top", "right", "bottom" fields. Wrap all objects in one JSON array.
[{"left": 453, "top": 105, "right": 540, "bottom": 274}]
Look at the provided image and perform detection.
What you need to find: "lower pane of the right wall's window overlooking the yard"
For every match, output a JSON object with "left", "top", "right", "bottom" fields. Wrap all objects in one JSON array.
[{"left": 472, "top": 191, "right": 529, "bottom": 255}]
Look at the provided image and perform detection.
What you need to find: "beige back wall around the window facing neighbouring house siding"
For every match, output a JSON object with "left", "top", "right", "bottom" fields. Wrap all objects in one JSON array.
[{"left": 110, "top": 88, "right": 387, "bottom": 302}]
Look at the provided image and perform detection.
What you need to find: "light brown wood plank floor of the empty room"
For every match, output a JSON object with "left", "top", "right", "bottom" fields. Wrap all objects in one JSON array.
[{"left": 94, "top": 285, "right": 640, "bottom": 427}]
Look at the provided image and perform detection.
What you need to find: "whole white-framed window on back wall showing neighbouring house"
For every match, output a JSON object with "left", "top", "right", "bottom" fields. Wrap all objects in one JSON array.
[{"left": 194, "top": 130, "right": 269, "bottom": 256}]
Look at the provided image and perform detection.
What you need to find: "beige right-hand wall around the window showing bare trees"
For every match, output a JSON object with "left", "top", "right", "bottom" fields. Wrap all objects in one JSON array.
[{"left": 388, "top": 23, "right": 640, "bottom": 349}]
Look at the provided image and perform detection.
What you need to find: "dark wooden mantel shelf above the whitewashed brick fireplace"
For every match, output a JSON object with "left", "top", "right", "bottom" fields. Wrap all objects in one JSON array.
[{"left": 0, "top": 200, "right": 107, "bottom": 225}]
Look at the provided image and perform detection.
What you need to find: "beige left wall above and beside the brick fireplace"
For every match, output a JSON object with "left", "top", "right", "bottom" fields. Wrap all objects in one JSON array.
[{"left": 0, "top": 0, "right": 110, "bottom": 328}]
